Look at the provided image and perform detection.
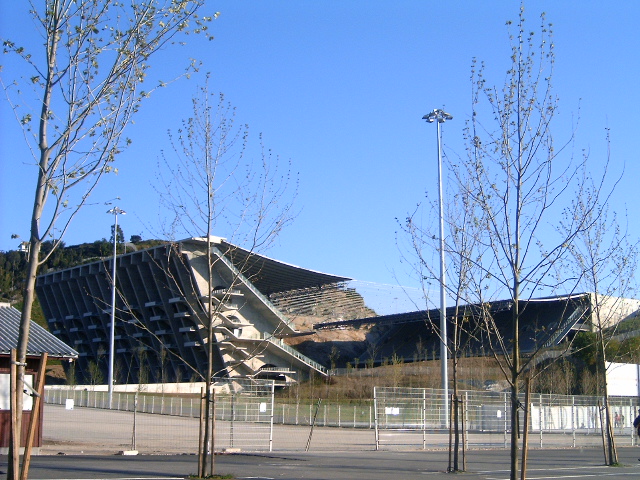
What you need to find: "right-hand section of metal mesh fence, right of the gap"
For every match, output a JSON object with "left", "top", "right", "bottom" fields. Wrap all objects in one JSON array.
[{"left": 374, "top": 387, "right": 639, "bottom": 449}]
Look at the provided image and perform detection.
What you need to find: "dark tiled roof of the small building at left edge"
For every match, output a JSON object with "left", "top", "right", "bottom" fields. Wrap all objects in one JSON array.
[{"left": 0, "top": 305, "right": 78, "bottom": 358}]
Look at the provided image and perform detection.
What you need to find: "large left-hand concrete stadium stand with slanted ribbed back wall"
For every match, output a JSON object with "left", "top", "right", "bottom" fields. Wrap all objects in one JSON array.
[{"left": 36, "top": 237, "right": 349, "bottom": 383}]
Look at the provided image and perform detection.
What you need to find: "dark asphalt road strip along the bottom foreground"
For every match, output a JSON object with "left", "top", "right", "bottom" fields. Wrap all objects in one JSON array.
[{"left": 0, "top": 447, "right": 640, "bottom": 480}]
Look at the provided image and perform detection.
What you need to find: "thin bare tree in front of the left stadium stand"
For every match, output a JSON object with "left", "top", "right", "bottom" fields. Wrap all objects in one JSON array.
[{"left": 152, "top": 79, "right": 297, "bottom": 477}]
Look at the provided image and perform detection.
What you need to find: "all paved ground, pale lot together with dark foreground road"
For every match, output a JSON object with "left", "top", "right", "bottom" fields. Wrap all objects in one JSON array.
[{"left": 5, "top": 406, "right": 640, "bottom": 480}]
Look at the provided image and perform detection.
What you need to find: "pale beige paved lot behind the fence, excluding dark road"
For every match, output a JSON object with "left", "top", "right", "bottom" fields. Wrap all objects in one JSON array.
[{"left": 42, "top": 405, "right": 620, "bottom": 455}]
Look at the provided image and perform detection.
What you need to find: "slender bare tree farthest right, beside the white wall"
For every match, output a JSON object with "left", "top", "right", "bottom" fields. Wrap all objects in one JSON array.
[{"left": 559, "top": 168, "right": 638, "bottom": 465}]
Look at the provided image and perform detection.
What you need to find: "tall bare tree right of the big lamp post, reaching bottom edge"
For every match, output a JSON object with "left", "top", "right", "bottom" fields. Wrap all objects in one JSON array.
[{"left": 450, "top": 7, "right": 599, "bottom": 480}]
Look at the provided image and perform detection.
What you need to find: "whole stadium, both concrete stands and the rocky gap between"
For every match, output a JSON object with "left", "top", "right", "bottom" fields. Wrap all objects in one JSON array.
[{"left": 36, "top": 237, "right": 639, "bottom": 384}]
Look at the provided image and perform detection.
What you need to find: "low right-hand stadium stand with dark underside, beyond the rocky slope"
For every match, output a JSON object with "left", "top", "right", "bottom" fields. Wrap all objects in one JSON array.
[{"left": 313, "top": 293, "right": 640, "bottom": 365}]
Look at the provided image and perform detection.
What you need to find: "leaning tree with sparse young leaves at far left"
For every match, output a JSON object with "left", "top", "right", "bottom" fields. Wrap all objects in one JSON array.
[{"left": 2, "top": 0, "right": 213, "bottom": 478}]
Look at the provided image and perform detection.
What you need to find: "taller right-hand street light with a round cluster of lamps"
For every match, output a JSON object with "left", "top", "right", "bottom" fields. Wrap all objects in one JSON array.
[{"left": 422, "top": 108, "right": 453, "bottom": 425}]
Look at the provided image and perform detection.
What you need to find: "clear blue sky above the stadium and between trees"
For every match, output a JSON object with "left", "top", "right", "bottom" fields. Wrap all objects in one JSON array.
[{"left": 0, "top": 0, "right": 640, "bottom": 316}]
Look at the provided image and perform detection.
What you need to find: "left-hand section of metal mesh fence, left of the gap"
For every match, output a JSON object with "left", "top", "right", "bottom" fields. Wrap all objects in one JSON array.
[{"left": 45, "top": 379, "right": 274, "bottom": 453}]
